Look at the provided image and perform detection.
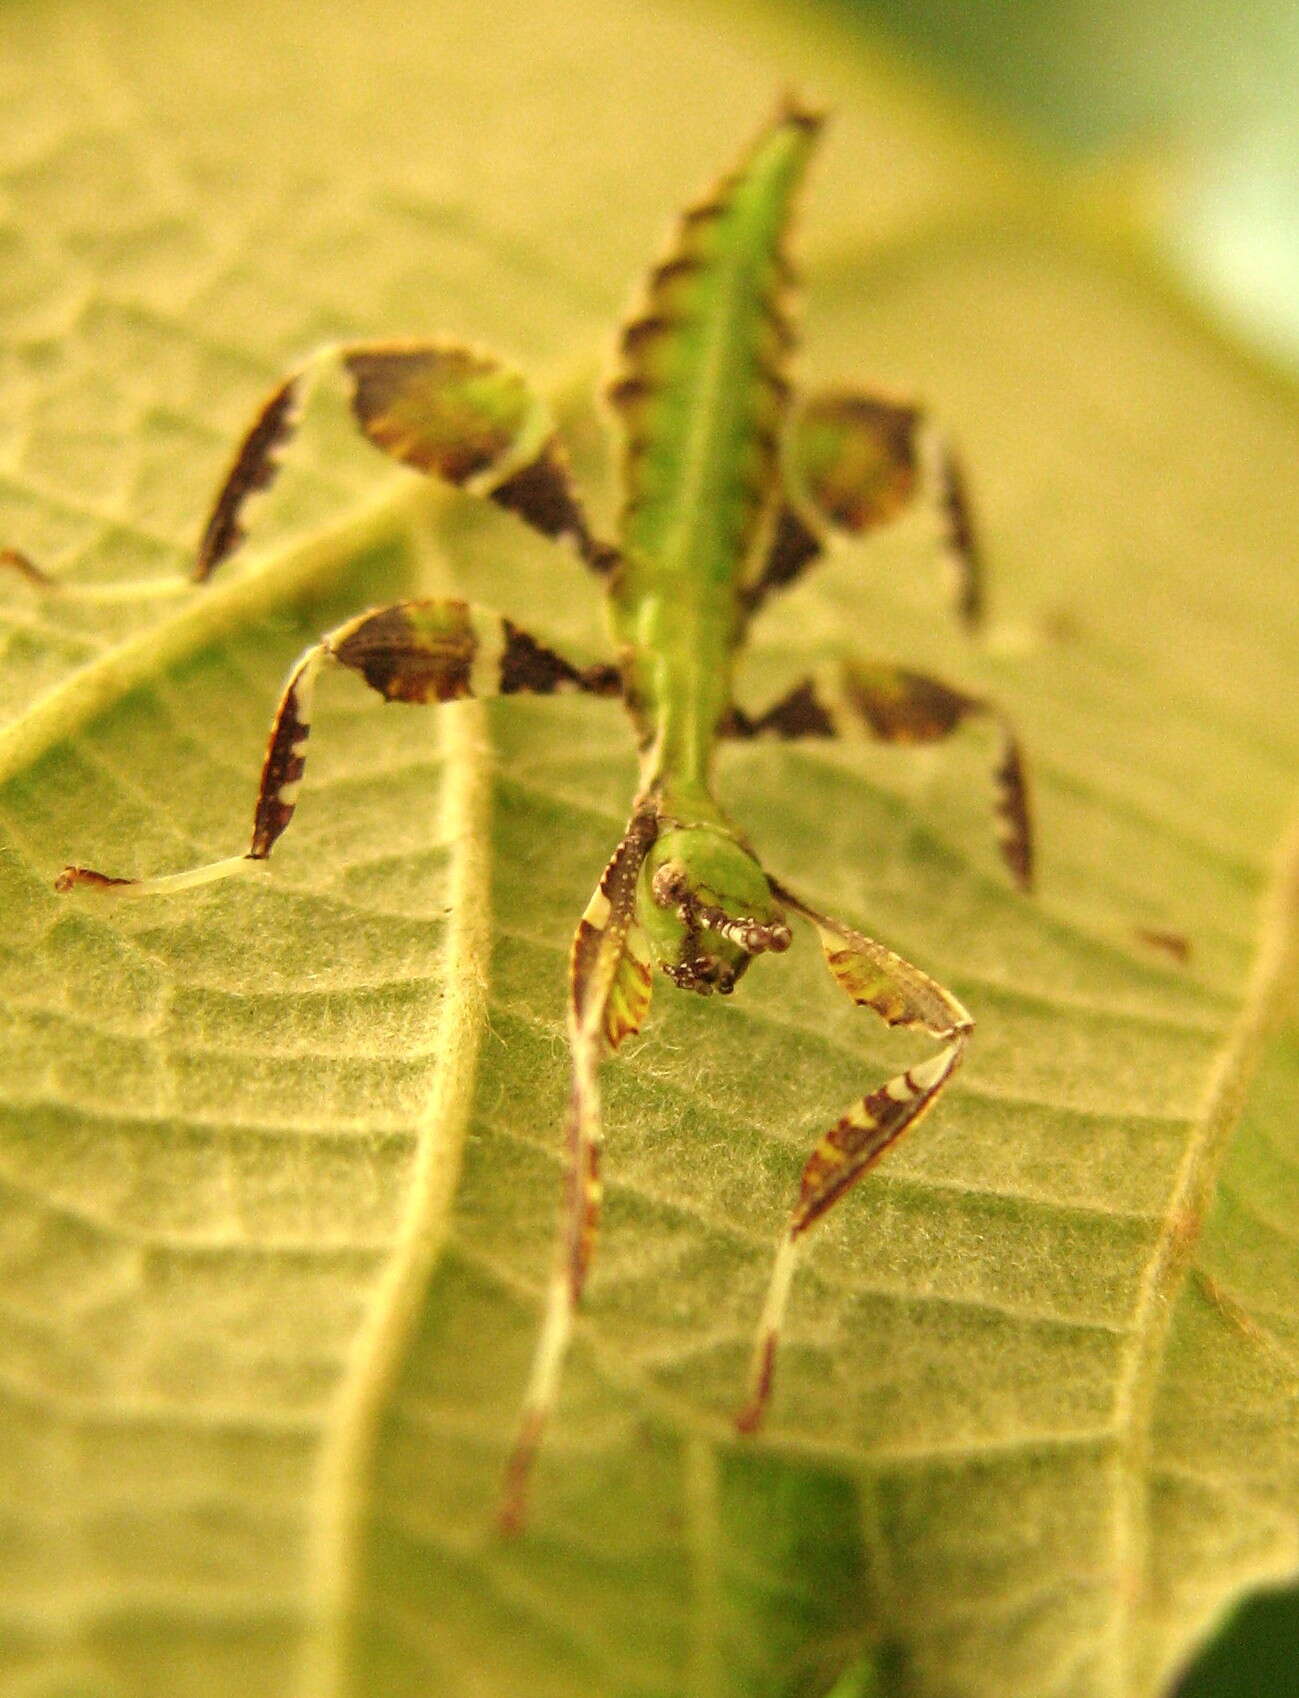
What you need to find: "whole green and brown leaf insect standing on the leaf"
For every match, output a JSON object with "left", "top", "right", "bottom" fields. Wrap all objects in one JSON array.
[{"left": 32, "top": 98, "right": 1032, "bottom": 1532}]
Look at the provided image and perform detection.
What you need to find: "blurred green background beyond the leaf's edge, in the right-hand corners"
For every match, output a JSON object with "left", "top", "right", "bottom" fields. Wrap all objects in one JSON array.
[{"left": 822, "top": 0, "right": 1299, "bottom": 1698}]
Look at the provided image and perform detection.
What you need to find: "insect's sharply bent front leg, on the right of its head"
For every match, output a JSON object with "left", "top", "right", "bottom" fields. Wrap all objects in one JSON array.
[{"left": 735, "top": 880, "right": 975, "bottom": 1433}]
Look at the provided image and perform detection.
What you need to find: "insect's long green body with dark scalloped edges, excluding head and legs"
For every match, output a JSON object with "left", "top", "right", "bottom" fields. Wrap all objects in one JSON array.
[{"left": 610, "top": 110, "right": 817, "bottom": 776}]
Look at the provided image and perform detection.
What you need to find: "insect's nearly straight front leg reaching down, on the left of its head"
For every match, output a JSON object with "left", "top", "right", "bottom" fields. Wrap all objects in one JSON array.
[{"left": 498, "top": 812, "right": 657, "bottom": 1533}]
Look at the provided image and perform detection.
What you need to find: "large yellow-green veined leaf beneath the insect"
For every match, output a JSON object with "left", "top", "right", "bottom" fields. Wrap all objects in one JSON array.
[{"left": 0, "top": 0, "right": 1299, "bottom": 1698}]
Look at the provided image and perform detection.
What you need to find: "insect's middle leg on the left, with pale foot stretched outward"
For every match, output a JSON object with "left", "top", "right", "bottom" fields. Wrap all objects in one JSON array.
[{"left": 56, "top": 598, "right": 621, "bottom": 897}]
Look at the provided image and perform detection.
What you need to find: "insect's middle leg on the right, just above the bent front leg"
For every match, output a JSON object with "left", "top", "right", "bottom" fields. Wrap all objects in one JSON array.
[{"left": 727, "top": 661, "right": 1032, "bottom": 890}]
